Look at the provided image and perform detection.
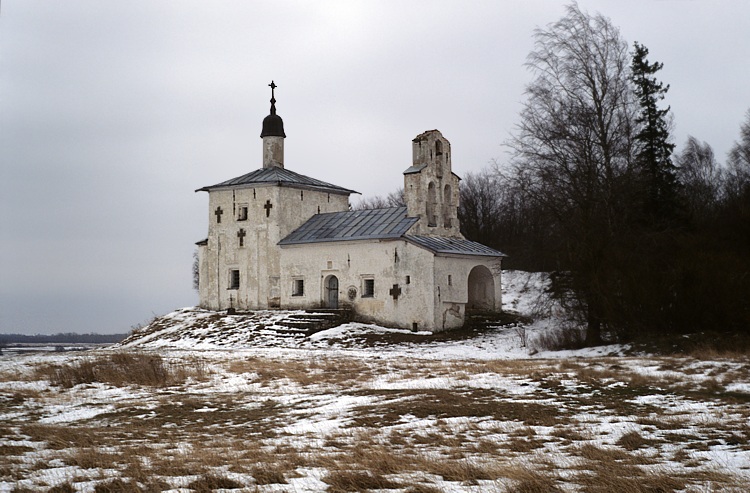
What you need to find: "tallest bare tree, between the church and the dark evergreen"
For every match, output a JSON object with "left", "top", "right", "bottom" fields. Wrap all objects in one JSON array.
[{"left": 509, "top": 3, "right": 636, "bottom": 344}]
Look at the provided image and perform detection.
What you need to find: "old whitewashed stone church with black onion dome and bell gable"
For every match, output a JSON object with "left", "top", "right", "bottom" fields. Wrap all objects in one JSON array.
[{"left": 196, "top": 82, "right": 504, "bottom": 331}]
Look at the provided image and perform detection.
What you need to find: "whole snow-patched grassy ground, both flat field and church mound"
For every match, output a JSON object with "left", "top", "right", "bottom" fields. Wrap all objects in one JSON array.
[{"left": 0, "top": 273, "right": 750, "bottom": 493}]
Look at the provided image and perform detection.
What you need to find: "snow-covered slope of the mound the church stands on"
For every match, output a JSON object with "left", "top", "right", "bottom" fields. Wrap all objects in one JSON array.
[{"left": 119, "top": 271, "right": 616, "bottom": 358}]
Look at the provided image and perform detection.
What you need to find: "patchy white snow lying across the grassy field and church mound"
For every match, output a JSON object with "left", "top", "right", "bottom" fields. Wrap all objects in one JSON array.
[{"left": 0, "top": 272, "right": 750, "bottom": 493}]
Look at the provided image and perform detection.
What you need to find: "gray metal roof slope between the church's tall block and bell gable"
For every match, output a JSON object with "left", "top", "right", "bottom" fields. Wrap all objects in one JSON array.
[{"left": 279, "top": 207, "right": 418, "bottom": 245}]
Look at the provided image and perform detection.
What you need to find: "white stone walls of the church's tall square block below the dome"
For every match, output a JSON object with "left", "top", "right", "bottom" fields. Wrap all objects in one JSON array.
[{"left": 199, "top": 186, "right": 349, "bottom": 310}]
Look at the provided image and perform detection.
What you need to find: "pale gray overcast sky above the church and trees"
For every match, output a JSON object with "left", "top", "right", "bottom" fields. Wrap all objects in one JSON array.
[{"left": 0, "top": 0, "right": 750, "bottom": 334}]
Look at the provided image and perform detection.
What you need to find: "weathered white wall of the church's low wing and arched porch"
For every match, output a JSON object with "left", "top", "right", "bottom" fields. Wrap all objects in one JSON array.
[{"left": 281, "top": 240, "right": 502, "bottom": 331}]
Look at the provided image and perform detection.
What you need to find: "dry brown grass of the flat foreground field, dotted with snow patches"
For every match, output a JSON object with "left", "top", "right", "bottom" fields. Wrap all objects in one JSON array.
[{"left": 0, "top": 353, "right": 750, "bottom": 493}]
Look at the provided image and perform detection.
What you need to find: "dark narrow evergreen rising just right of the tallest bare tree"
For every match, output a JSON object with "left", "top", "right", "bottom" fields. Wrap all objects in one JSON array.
[{"left": 631, "top": 42, "right": 678, "bottom": 223}]
